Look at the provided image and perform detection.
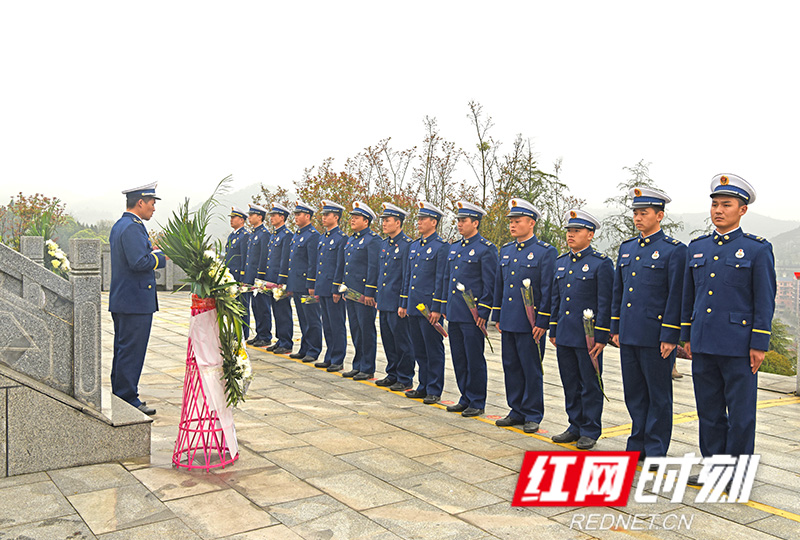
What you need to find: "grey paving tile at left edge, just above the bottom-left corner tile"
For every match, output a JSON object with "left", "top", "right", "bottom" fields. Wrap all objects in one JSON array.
[{"left": 0, "top": 480, "right": 75, "bottom": 527}]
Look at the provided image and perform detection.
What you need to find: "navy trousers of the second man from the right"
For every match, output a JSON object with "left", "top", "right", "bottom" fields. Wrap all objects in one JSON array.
[{"left": 619, "top": 343, "right": 675, "bottom": 457}]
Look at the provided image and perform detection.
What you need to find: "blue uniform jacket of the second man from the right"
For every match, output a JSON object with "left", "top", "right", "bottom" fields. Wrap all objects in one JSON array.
[{"left": 611, "top": 230, "right": 686, "bottom": 347}]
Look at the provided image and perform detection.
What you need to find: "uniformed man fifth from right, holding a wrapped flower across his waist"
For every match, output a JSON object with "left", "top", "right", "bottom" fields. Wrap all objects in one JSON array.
[{"left": 442, "top": 201, "right": 497, "bottom": 417}]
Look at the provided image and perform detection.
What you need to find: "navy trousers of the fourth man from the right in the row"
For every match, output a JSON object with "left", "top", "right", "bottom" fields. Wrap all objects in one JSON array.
[{"left": 500, "top": 332, "right": 547, "bottom": 424}]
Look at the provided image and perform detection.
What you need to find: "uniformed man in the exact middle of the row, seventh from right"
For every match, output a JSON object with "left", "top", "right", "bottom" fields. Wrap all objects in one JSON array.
[{"left": 375, "top": 203, "right": 414, "bottom": 392}]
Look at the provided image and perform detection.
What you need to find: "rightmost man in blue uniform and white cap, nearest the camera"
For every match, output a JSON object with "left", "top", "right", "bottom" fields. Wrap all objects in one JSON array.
[{"left": 681, "top": 174, "right": 776, "bottom": 483}]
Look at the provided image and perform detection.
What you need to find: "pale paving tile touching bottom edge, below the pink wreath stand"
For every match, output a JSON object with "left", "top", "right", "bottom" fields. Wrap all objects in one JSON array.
[{"left": 165, "top": 489, "right": 277, "bottom": 539}]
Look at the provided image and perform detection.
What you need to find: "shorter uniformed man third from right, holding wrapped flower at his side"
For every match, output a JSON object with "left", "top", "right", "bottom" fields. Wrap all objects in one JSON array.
[{"left": 550, "top": 208, "right": 614, "bottom": 450}]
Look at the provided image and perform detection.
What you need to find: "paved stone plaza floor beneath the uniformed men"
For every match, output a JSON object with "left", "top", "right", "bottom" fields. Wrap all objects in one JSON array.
[{"left": 0, "top": 292, "right": 800, "bottom": 540}]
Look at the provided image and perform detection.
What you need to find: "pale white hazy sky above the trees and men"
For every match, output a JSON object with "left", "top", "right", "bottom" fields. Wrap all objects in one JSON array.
[{"left": 0, "top": 0, "right": 800, "bottom": 225}]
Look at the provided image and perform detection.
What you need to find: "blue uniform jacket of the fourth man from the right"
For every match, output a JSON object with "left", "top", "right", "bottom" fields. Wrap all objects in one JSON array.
[{"left": 492, "top": 235, "right": 558, "bottom": 333}]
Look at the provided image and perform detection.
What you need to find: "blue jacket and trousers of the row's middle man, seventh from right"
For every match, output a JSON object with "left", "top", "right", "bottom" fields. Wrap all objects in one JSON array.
[{"left": 375, "top": 231, "right": 414, "bottom": 386}]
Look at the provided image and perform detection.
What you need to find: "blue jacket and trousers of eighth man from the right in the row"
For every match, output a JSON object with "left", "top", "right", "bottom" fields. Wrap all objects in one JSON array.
[{"left": 344, "top": 228, "right": 381, "bottom": 374}]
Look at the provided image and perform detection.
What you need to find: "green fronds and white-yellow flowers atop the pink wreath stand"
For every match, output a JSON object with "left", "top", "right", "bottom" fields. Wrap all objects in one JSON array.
[{"left": 158, "top": 176, "right": 252, "bottom": 407}]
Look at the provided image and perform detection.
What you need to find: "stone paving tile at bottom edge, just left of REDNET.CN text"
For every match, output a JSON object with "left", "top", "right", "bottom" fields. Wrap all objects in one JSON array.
[{"left": 458, "top": 502, "right": 590, "bottom": 540}]
